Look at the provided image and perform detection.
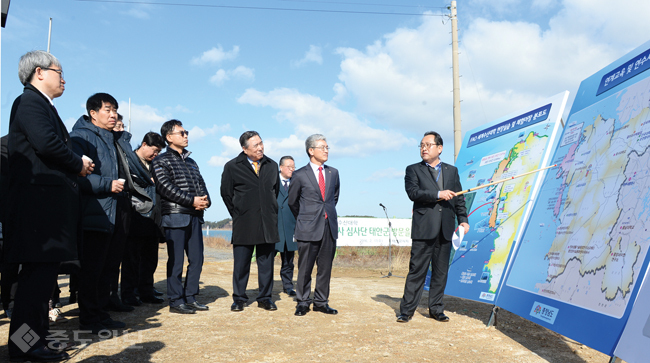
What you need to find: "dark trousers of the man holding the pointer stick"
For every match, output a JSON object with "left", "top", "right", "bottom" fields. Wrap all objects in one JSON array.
[{"left": 399, "top": 234, "right": 451, "bottom": 315}]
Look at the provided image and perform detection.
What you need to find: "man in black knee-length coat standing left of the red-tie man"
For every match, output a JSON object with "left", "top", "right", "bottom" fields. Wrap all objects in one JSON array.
[{"left": 221, "top": 131, "right": 280, "bottom": 311}]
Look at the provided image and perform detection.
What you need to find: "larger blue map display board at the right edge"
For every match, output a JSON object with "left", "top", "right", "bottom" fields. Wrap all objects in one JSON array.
[{"left": 497, "top": 42, "right": 650, "bottom": 354}]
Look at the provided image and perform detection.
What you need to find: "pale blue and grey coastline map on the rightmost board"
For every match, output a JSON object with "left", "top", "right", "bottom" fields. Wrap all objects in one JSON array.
[{"left": 507, "top": 74, "right": 650, "bottom": 317}]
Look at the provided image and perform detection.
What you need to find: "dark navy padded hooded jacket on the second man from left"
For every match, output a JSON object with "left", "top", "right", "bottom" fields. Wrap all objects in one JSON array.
[{"left": 70, "top": 115, "right": 133, "bottom": 233}]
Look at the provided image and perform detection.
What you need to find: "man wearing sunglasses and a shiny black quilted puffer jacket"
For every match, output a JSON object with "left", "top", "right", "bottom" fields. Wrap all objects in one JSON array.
[{"left": 153, "top": 120, "right": 211, "bottom": 314}]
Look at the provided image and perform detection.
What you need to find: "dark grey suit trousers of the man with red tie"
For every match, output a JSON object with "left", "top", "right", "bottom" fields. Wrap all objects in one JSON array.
[{"left": 296, "top": 219, "right": 336, "bottom": 306}]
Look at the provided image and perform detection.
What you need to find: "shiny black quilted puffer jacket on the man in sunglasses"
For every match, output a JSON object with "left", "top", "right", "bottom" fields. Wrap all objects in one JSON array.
[{"left": 153, "top": 146, "right": 212, "bottom": 217}]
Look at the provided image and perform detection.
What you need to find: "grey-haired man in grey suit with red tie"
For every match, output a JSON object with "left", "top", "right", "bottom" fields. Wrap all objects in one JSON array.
[{"left": 288, "top": 134, "right": 340, "bottom": 316}]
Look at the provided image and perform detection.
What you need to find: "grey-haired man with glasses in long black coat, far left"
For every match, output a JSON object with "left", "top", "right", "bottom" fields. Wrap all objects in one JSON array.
[{"left": 3, "top": 51, "right": 94, "bottom": 362}]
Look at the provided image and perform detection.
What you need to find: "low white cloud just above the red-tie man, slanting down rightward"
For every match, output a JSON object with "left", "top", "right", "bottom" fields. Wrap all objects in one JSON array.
[{"left": 238, "top": 88, "right": 413, "bottom": 156}]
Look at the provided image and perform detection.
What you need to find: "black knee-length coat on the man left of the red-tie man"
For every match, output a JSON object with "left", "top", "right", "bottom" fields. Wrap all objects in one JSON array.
[{"left": 221, "top": 152, "right": 280, "bottom": 245}]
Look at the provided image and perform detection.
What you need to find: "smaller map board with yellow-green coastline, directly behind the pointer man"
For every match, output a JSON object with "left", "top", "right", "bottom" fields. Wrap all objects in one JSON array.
[{"left": 440, "top": 92, "right": 569, "bottom": 304}]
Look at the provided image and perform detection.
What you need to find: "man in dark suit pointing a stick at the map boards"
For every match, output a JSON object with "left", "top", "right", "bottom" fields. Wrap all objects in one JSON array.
[{"left": 397, "top": 131, "right": 469, "bottom": 323}]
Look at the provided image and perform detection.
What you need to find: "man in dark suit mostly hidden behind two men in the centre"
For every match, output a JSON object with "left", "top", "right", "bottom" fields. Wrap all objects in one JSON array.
[{"left": 275, "top": 156, "right": 298, "bottom": 296}]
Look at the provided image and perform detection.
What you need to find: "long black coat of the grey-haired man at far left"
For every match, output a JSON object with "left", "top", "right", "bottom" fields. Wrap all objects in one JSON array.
[{"left": 2, "top": 85, "right": 83, "bottom": 263}]
